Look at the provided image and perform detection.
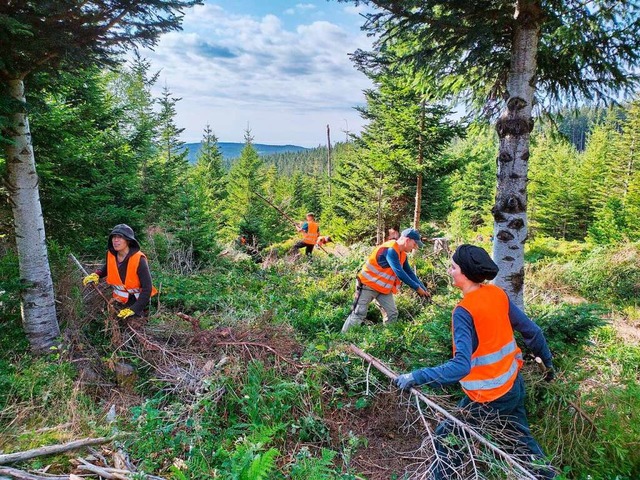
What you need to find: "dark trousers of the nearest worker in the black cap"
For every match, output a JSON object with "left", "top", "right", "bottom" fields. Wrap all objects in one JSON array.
[{"left": 432, "top": 373, "right": 555, "bottom": 480}]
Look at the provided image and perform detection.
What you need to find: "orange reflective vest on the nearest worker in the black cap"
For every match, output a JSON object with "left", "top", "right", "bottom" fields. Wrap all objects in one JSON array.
[{"left": 453, "top": 284, "right": 523, "bottom": 403}]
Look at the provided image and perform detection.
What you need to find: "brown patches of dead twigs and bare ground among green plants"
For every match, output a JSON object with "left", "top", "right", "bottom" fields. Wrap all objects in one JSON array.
[{"left": 79, "top": 313, "right": 424, "bottom": 480}]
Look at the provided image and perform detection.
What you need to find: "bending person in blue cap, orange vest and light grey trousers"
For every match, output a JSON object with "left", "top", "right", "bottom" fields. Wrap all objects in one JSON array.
[{"left": 342, "top": 228, "right": 430, "bottom": 333}]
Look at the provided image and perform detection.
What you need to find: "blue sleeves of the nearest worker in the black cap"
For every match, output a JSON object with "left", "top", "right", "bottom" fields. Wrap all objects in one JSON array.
[{"left": 412, "top": 300, "right": 553, "bottom": 386}]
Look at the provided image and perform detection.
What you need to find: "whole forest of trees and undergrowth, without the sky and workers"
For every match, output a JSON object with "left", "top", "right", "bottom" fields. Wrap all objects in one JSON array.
[{"left": 0, "top": 0, "right": 640, "bottom": 480}]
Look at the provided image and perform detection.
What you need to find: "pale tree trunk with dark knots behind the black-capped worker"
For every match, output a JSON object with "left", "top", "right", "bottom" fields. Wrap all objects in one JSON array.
[{"left": 492, "top": 0, "right": 542, "bottom": 307}]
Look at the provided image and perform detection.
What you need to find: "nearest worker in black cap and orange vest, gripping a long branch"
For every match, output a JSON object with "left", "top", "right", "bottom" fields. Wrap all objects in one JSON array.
[{"left": 396, "top": 245, "right": 555, "bottom": 479}]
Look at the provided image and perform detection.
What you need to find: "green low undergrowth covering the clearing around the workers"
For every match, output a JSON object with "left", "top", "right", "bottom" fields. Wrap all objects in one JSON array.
[{"left": 0, "top": 242, "right": 640, "bottom": 480}]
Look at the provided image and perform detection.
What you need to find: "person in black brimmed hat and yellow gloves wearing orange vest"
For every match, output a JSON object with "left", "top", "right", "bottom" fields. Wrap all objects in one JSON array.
[{"left": 82, "top": 223, "right": 157, "bottom": 319}]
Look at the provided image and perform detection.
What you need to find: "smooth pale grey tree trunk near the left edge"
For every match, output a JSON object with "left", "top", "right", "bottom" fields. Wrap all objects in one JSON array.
[{"left": 5, "top": 79, "right": 60, "bottom": 353}]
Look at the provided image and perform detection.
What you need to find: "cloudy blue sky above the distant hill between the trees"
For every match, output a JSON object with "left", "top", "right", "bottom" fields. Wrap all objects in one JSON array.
[{"left": 136, "top": 0, "right": 371, "bottom": 147}]
